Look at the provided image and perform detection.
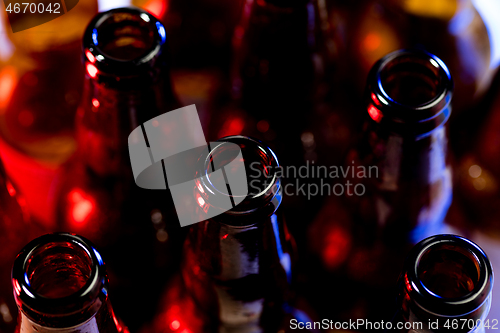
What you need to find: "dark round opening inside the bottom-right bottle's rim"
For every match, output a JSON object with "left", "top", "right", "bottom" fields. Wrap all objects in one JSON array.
[{"left": 417, "top": 244, "right": 480, "bottom": 298}]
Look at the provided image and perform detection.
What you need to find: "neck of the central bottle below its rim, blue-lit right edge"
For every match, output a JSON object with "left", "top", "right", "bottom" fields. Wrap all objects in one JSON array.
[{"left": 183, "top": 210, "right": 293, "bottom": 331}]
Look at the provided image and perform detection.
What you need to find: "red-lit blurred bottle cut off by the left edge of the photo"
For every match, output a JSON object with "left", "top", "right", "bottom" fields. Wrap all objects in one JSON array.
[{"left": 0, "top": 156, "right": 41, "bottom": 332}]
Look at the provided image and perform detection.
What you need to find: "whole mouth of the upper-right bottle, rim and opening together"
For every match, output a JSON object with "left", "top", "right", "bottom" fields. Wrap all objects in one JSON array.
[{"left": 367, "top": 50, "right": 453, "bottom": 136}]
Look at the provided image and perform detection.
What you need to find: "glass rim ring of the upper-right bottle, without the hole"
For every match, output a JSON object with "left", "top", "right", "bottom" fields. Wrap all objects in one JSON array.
[{"left": 366, "top": 49, "right": 453, "bottom": 137}]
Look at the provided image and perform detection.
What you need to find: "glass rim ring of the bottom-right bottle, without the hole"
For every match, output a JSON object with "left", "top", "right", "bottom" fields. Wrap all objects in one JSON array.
[{"left": 403, "top": 235, "right": 494, "bottom": 316}]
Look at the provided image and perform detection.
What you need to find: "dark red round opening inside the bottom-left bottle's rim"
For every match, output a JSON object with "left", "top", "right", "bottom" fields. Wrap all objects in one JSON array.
[{"left": 26, "top": 242, "right": 92, "bottom": 299}]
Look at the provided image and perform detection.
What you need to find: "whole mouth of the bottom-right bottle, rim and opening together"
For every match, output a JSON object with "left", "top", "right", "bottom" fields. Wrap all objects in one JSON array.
[{"left": 405, "top": 235, "right": 493, "bottom": 316}]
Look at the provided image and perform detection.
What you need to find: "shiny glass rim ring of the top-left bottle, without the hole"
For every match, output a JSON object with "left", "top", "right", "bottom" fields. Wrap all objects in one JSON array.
[{"left": 83, "top": 7, "right": 167, "bottom": 78}]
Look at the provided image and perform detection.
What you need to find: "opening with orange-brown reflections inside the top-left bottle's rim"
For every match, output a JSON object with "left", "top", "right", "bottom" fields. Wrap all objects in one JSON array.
[{"left": 92, "top": 12, "right": 158, "bottom": 61}]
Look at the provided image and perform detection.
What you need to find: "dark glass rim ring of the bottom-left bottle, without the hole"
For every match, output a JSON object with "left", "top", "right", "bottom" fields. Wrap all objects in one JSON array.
[{"left": 12, "top": 233, "right": 107, "bottom": 327}]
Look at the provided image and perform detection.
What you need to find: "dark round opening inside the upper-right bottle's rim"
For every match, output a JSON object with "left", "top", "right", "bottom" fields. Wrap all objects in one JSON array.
[{"left": 380, "top": 55, "right": 445, "bottom": 107}]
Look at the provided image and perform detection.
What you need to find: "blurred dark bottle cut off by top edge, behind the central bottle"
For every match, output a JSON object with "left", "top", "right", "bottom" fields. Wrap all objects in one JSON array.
[{"left": 210, "top": 0, "right": 335, "bottom": 165}]
